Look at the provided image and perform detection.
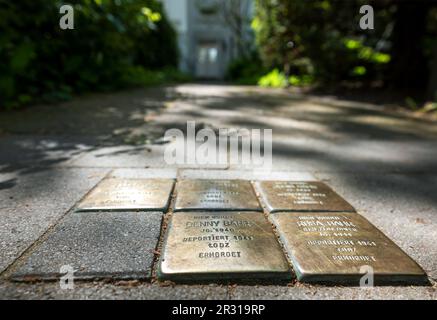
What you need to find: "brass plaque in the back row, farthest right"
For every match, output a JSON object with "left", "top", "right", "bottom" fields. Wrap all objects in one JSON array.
[{"left": 255, "top": 181, "right": 355, "bottom": 213}]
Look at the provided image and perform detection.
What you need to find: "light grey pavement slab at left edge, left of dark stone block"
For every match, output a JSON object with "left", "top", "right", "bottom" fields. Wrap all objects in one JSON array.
[{"left": 0, "top": 168, "right": 108, "bottom": 271}]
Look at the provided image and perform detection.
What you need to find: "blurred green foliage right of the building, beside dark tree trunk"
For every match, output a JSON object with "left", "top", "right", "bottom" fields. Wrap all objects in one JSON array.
[{"left": 252, "top": 0, "right": 392, "bottom": 83}]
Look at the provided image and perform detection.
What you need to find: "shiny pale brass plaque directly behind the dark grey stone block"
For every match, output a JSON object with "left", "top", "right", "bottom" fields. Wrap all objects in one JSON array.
[{"left": 78, "top": 178, "right": 174, "bottom": 211}]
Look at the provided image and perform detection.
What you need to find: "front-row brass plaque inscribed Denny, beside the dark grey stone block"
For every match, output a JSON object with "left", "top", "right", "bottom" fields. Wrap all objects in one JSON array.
[{"left": 158, "top": 212, "right": 291, "bottom": 281}]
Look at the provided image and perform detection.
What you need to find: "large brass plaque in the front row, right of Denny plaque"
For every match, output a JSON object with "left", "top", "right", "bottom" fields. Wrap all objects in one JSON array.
[{"left": 270, "top": 212, "right": 426, "bottom": 286}]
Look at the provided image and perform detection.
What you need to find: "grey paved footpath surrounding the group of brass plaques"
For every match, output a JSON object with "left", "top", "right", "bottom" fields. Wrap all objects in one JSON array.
[{"left": 0, "top": 84, "right": 437, "bottom": 299}]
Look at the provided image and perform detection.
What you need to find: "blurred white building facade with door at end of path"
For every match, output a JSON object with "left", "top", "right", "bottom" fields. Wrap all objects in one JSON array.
[{"left": 161, "top": 0, "right": 254, "bottom": 79}]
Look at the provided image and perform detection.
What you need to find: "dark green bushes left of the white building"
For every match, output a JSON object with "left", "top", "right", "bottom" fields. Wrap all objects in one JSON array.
[{"left": 0, "top": 0, "right": 178, "bottom": 108}]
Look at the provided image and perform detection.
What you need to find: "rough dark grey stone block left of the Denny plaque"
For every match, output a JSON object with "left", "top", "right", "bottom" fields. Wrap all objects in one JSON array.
[{"left": 12, "top": 212, "right": 162, "bottom": 280}]
